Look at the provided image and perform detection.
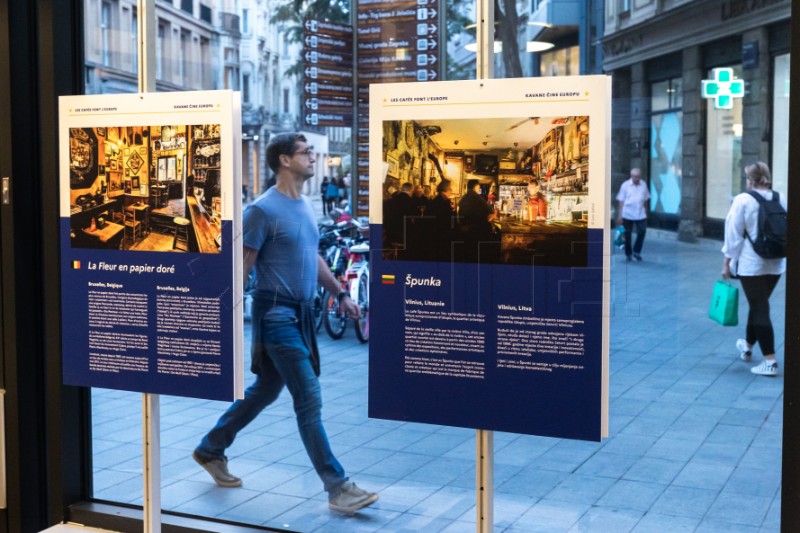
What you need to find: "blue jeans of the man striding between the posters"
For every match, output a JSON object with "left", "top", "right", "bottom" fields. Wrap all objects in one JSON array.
[{"left": 196, "top": 314, "right": 347, "bottom": 495}]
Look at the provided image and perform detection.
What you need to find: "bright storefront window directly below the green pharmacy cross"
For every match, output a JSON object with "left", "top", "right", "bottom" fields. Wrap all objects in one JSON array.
[{"left": 706, "top": 65, "right": 743, "bottom": 219}]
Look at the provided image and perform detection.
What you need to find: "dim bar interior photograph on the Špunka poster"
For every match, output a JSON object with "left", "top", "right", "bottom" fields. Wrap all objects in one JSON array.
[{"left": 382, "top": 116, "right": 589, "bottom": 267}]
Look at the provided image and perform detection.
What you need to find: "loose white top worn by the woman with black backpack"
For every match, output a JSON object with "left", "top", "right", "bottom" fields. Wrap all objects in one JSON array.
[{"left": 722, "top": 189, "right": 786, "bottom": 276}]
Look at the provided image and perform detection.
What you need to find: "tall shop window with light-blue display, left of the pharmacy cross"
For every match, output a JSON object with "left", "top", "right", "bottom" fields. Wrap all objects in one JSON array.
[{"left": 649, "top": 78, "right": 683, "bottom": 215}]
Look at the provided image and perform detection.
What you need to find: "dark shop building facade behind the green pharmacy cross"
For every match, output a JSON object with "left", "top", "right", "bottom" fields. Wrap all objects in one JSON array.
[{"left": 602, "top": 0, "right": 791, "bottom": 241}]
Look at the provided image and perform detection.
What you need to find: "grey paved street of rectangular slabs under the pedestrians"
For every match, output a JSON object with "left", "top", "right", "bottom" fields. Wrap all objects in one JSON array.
[{"left": 93, "top": 227, "right": 785, "bottom": 533}]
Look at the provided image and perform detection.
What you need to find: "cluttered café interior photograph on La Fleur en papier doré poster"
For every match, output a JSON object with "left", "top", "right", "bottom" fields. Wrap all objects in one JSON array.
[{"left": 69, "top": 124, "right": 222, "bottom": 253}]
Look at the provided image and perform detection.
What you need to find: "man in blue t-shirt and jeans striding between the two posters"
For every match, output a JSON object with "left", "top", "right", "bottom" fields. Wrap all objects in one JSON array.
[{"left": 192, "top": 133, "right": 378, "bottom": 514}]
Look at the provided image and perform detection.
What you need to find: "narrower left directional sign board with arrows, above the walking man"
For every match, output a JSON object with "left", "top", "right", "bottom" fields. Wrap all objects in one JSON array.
[{"left": 303, "top": 19, "right": 353, "bottom": 126}]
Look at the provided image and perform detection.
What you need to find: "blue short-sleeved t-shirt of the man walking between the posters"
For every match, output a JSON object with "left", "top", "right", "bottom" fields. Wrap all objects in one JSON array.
[{"left": 242, "top": 187, "right": 319, "bottom": 314}]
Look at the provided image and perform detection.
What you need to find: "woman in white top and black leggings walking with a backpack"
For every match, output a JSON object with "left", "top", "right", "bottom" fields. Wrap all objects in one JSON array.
[{"left": 722, "top": 161, "right": 786, "bottom": 376}]
